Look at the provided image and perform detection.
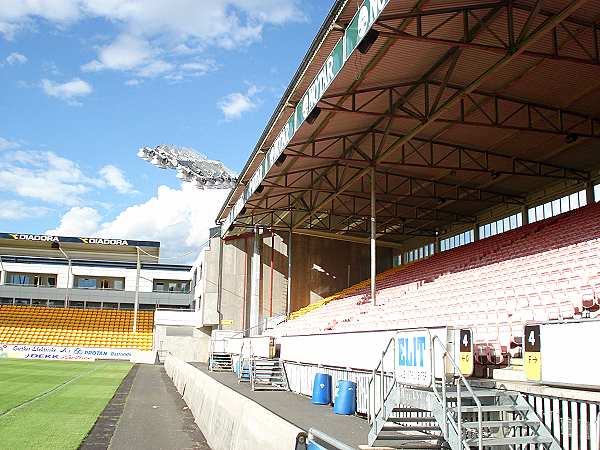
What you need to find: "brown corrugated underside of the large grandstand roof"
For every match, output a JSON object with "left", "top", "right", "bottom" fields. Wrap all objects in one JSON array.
[{"left": 221, "top": 0, "right": 600, "bottom": 243}]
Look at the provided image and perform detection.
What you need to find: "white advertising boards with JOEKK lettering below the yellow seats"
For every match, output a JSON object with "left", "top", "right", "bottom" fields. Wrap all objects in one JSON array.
[{"left": 0, "top": 344, "right": 138, "bottom": 361}]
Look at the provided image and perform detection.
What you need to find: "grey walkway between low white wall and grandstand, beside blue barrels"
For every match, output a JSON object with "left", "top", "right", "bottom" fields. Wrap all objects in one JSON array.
[{"left": 192, "top": 363, "right": 369, "bottom": 448}]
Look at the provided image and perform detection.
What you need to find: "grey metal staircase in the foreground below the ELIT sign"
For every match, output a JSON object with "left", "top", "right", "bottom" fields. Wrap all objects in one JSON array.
[{"left": 369, "top": 328, "right": 561, "bottom": 450}]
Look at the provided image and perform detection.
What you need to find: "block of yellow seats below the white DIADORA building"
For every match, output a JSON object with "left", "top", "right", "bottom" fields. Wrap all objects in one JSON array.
[{"left": 0, "top": 305, "right": 154, "bottom": 350}]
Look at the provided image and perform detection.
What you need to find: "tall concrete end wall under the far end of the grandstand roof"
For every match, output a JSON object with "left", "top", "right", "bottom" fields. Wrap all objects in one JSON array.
[{"left": 195, "top": 232, "right": 393, "bottom": 330}]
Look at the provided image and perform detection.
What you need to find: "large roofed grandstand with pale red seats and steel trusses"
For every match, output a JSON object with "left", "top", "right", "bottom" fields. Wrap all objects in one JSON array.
[{"left": 166, "top": 0, "right": 600, "bottom": 450}]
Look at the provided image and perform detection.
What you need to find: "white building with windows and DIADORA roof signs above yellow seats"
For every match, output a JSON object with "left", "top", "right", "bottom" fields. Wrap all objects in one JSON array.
[{"left": 0, "top": 233, "right": 195, "bottom": 310}]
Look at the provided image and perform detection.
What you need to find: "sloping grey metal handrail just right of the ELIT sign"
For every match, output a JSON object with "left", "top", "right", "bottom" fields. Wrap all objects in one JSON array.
[{"left": 431, "top": 336, "right": 483, "bottom": 450}]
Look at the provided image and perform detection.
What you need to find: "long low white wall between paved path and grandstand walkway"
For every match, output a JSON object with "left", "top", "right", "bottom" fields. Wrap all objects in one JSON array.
[{"left": 165, "top": 355, "right": 304, "bottom": 450}]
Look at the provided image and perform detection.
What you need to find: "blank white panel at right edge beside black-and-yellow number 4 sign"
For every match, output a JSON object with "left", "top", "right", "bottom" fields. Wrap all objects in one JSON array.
[{"left": 536, "top": 319, "right": 600, "bottom": 387}]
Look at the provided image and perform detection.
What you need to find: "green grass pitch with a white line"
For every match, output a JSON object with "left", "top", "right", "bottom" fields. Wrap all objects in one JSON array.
[{"left": 0, "top": 359, "right": 132, "bottom": 450}]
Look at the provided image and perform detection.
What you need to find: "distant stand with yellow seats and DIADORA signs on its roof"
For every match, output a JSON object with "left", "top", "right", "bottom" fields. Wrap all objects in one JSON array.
[{"left": 0, "top": 233, "right": 196, "bottom": 361}]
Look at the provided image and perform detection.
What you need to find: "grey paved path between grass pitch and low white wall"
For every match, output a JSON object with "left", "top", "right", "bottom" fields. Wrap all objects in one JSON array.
[{"left": 109, "top": 365, "right": 210, "bottom": 450}]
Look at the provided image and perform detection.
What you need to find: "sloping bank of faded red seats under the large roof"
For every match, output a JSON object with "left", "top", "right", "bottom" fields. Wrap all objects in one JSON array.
[{"left": 273, "top": 205, "right": 600, "bottom": 364}]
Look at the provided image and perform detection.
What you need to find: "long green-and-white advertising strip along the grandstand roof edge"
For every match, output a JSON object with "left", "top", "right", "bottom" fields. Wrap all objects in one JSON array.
[{"left": 221, "top": 0, "right": 389, "bottom": 236}]
